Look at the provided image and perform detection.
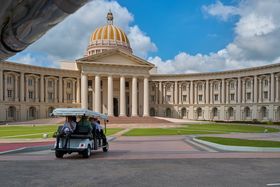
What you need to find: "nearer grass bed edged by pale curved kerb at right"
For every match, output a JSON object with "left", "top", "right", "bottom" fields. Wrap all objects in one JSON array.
[{"left": 197, "top": 137, "right": 280, "bottom": 148}]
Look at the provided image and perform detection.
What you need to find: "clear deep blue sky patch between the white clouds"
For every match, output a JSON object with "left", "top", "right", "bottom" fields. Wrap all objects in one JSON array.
[{"left": 118, "top": 0, "right": 237, "bottom": 60}]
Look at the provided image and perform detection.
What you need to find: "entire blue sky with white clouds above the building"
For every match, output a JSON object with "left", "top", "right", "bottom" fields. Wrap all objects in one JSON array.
[{"left": 8, "top": 0, "right": 280, "bottom": 73}]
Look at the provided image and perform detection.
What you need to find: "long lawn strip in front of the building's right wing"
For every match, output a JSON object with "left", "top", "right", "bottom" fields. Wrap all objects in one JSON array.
[{"left": 124, "top": 124, "right": 279, "bottom": 136}]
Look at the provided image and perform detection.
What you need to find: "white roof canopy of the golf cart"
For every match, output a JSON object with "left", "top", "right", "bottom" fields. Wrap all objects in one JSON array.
[{"left": 52, "top": 108, "right": 108, "bottom": 120}]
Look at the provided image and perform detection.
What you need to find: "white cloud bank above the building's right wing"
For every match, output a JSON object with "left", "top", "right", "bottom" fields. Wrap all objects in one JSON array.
[{"left": 149, "top": 0, "right": 280, "bottom": 73}]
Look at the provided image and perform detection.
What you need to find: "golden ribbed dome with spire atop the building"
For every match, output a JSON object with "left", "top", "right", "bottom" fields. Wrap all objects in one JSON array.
[{"left": 86, "top": 12, "right": 132, "bottom": 56}]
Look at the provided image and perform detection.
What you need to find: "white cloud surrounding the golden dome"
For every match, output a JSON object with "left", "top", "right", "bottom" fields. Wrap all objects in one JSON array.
[{"left": 16, "top": 0, "right": 156, "bottom": 64}]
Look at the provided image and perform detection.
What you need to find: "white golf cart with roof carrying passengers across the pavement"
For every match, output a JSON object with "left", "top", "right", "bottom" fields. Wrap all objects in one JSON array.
[{"left": 51, "top": 108, "right": 109, "bottom": 158}]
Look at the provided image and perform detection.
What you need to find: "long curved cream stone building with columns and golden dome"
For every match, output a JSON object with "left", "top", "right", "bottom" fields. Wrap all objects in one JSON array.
[{"left": 0, "top": 12, "right": 280, "bottom": 121}]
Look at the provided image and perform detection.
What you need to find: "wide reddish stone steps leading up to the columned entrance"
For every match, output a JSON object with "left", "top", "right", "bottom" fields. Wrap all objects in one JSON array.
[{"left": 109, "top": 117, "right": 171, "bottom": 124}]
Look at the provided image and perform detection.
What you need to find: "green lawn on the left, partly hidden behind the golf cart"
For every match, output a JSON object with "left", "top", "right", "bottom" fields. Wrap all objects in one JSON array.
[{"left": 0, "top": 125, "right": 122, "bottom": 139}]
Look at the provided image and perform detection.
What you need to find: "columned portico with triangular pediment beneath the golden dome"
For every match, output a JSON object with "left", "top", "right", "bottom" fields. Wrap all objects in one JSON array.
[{"left": 77, "top": 49, "right": 154, "bottom": 116}]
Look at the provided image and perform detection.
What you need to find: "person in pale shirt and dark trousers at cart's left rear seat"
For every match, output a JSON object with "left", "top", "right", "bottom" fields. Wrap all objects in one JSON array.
[{"left": 56, "top": 116, "right": 77, "bottom": 148}]
